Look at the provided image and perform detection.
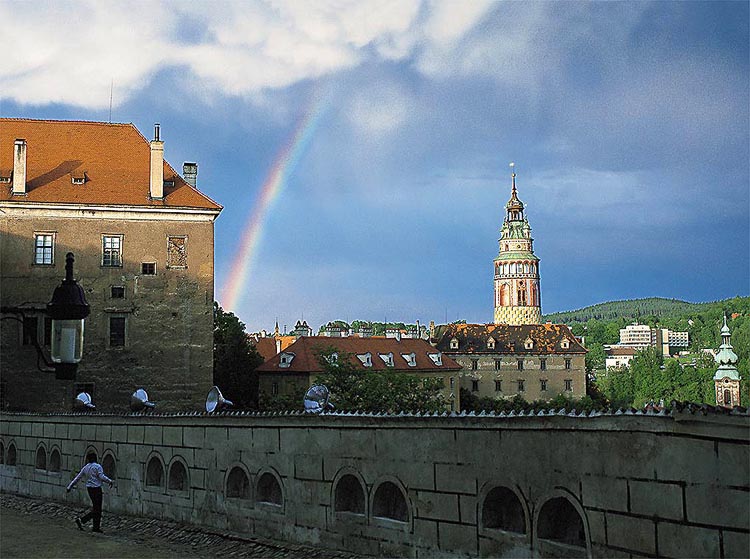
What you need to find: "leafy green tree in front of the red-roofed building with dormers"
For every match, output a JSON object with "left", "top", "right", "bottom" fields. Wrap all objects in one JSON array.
[{"left": 316, "top": 348, "right": 446, "bottom": 413}]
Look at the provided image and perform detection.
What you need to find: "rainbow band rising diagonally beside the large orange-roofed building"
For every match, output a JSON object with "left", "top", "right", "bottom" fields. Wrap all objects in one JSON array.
[{"left": 220, "top": 89, "right": 329, "bottom": 310}]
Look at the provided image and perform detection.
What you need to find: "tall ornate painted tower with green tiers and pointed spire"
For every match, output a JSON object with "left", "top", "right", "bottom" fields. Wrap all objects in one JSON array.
[{"left": 494, "top": 163, "right": 542, "bottom": 324}]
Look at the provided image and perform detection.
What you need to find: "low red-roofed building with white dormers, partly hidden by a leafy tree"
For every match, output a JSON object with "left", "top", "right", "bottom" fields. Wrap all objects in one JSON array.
[{"left": 256, "top": 336, "right": 461, "bottom": 410}]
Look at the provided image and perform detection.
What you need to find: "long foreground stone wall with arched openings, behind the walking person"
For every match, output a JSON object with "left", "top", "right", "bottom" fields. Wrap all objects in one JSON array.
[{"left": 0, "top": 412, "right": 750, "bottom": 557}]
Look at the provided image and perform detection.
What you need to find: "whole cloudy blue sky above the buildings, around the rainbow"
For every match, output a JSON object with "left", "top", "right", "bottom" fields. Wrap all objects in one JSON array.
[{"left": 0, "top": 0, "right": 750, "bottom": 331}]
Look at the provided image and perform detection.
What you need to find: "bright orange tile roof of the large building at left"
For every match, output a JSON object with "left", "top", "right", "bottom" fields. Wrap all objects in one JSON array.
[{"left": 0, "top": 118, "right": 221, "bottom": 211}]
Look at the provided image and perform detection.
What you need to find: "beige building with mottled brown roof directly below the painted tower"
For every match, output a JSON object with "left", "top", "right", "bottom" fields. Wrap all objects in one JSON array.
[{"left": 432, "top": 323, "right": 586, "bottom": 401}]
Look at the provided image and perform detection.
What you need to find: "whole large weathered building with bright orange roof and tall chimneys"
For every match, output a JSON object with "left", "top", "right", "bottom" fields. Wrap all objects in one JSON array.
[{"left": 0, "top": 119, "right": 221, "bottom": 411}]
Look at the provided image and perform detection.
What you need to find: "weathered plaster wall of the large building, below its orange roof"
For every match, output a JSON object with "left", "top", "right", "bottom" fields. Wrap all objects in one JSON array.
[{"left": 0, "top": 214, "right": 214, "bottom": 411}]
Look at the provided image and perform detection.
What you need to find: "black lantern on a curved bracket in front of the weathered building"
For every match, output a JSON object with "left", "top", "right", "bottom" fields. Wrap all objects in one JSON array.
[{"left": 0, "top": 252, "right": 91, "bottom": 380}]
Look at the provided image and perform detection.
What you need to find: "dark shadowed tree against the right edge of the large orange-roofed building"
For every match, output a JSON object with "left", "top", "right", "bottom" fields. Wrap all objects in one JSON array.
[{"left": 214, "top": 302, "right": 263, "bottom": 409}]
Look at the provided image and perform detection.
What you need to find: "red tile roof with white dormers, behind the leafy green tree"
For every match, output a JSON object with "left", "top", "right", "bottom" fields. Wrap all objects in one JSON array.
[{"left": 256, "top": 336, "right": 461, "bottom": 373}]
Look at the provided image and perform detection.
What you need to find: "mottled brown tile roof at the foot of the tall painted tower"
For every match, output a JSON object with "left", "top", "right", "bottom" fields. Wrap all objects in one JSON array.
[{"left": 432, "top": 324, "right": 588, "bottom": 355}]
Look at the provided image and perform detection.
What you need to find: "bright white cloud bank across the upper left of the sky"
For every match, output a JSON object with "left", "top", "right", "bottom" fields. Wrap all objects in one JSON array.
[{"left": 0, "top": 0, "right": 500, "bottom": 108}]
